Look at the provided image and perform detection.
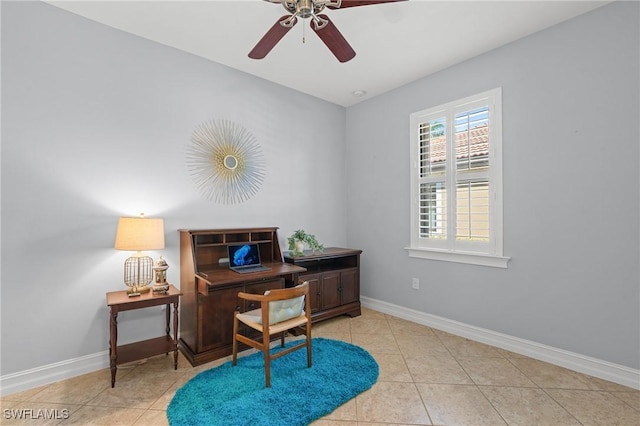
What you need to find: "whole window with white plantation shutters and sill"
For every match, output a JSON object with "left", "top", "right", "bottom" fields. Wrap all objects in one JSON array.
[{"left": 407, "top": 88, "right": 508, "bottom": 268}]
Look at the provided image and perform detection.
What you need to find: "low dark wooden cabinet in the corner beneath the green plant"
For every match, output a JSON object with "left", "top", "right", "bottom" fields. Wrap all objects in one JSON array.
[{"left": 284, "top": 247, "right": 362, "bottom": 322}]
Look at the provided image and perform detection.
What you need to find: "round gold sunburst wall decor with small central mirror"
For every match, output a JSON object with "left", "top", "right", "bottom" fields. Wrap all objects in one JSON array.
[{"left": 187, "top": 120, "right": 265, "bottom": 204}]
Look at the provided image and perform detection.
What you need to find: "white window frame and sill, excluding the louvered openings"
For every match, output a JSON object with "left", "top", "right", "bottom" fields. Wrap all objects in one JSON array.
[{"left": 406, "top": 87, "right": 509, "bottom": 268}]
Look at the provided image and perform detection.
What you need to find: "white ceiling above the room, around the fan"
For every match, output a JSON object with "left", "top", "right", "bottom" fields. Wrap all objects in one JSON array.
[{"left": 47, "top": 0, "right": 609, "bottom": 106}]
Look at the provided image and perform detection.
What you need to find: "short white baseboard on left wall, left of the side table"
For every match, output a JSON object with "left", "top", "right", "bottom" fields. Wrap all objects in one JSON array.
[{"left": 0, "top": 351, "right": 109, "bottom": 396}]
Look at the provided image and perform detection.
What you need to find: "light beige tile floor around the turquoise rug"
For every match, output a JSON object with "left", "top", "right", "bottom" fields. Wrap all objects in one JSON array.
[{"left": 0, "top": 309, "right": 640, "bottom": 426}]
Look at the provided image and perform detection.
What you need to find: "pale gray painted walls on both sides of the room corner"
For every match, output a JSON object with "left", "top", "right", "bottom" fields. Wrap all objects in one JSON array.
[{"left": 0, "top": 2, "right": 640, "bottom": 375}]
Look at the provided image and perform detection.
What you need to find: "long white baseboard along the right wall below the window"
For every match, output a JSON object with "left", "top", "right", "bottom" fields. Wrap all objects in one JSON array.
[{"left": 360, "top": 296, "right": 640, "bottom": 390}]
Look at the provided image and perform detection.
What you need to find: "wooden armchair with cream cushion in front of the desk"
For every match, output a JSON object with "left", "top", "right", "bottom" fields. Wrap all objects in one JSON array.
[{"left": 233, "top": 281, "right": 311, "bottom": 387}]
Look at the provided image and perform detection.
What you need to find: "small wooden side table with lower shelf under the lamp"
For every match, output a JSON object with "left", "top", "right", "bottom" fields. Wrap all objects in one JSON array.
[{"left": 107, "top": 285, "right": 182, "bottom": 387}]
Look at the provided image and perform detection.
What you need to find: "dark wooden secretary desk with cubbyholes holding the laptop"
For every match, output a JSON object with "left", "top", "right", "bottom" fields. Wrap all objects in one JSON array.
[{"left": 178, "top": 228, "right": 305, "bottom": 366}]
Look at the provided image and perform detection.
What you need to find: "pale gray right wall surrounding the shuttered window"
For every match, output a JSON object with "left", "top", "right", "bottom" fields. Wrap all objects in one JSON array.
[{"left": 346, "top": 2, "right": 640, "bottom": 369}]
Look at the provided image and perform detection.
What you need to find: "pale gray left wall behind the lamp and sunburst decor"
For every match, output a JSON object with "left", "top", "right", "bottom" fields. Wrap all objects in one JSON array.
[{"left": 1, "top": 2, "right": 346, "bottom": 375}]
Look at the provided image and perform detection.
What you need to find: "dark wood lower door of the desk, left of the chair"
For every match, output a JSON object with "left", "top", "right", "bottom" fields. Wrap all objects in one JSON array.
[{"left": 197, "top": 287, "right": 240, "bottom": 352}]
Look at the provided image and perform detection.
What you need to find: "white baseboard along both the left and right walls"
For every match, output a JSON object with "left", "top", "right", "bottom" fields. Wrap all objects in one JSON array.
[{"left": 0, "top": 296, "right": 640, "bottom": 396}]
